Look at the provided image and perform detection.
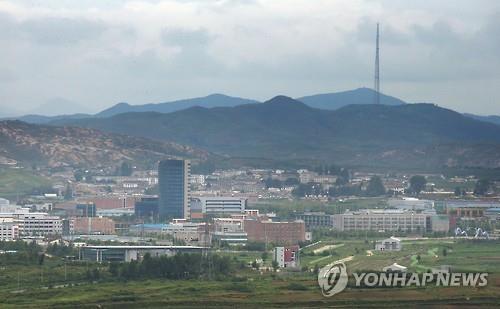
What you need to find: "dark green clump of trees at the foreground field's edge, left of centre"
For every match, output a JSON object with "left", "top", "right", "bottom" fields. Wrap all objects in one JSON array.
[{"left": 109, "top": 253, "right": 235, "bottom": 280}]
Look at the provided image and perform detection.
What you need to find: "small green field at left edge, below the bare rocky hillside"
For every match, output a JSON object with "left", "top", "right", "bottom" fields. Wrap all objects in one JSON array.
[{"left": 0, "top": 167, "right": 51, "bottom": 199}]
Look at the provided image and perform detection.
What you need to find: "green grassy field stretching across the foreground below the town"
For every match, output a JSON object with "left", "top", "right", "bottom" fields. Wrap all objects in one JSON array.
[{"left": 0, "top": 239, "right": 500, "bottom": 308}]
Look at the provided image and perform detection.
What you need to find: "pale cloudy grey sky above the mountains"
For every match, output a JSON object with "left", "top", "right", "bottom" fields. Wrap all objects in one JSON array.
[{"left": 0, "top": 0, "right": 500, "bottom": 115}]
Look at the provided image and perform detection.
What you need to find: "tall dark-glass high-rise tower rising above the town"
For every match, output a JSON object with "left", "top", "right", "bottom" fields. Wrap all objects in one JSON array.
[{"left": 158, "top": 160, "right": 191, "bottom": 219}]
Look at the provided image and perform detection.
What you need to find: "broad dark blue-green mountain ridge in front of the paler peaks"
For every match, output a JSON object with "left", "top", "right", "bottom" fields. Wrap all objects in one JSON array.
[{"left": 51, "top": 96, "right": 500, "bottom": 167}]
